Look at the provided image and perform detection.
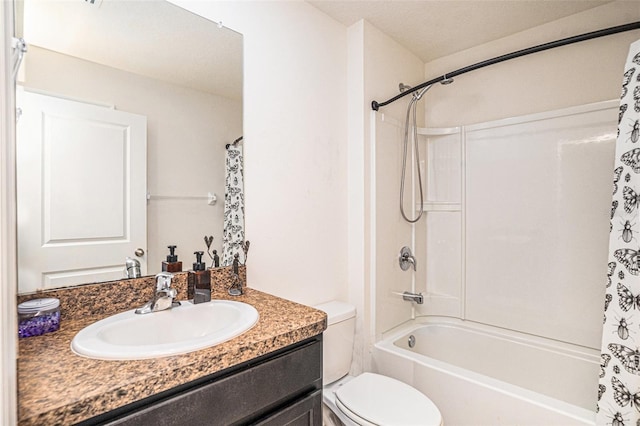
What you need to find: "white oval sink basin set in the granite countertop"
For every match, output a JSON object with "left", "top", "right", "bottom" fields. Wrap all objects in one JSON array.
[{"left": 71, "top": 300, "right": 258, "bottom": 360}]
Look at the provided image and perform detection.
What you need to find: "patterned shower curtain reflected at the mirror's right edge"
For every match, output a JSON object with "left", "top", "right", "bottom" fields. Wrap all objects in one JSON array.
[{"left": 220, "top": 145, "right": 244, "bottom": 266}]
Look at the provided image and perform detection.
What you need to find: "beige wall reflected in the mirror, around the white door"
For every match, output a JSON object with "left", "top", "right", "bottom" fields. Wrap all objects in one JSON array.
[{"left": 24, "top": 46, "right": 242, "bottom": 273}]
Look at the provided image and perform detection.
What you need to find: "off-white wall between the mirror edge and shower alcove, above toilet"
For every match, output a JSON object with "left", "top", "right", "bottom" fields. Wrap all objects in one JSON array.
[{"left": 172, "top": 0, "right": 347, "bottom": 305}]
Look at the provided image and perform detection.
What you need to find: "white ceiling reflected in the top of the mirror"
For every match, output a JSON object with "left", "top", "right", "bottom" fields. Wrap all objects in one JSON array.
[{"left": 24, "top": 0, "right": 242, "bottom": 99}]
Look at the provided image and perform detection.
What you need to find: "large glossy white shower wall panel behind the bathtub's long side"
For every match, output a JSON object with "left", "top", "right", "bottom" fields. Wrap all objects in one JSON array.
[{"left": 464, "top": 101, "right": 621, "bottom": 348}]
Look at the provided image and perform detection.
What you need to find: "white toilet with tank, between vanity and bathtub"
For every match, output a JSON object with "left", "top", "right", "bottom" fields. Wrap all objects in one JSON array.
[{"left": 316, "top": 301, "right": 442, "bottom": 426}]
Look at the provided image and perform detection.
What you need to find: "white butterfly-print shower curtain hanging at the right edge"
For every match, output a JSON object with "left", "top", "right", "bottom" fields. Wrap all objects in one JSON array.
[{"left": 596, "top": 40, "right": 640, "bottom": 425}]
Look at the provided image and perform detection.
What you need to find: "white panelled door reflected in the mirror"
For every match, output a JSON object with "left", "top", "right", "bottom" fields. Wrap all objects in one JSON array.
[{"left": 16, "top": 90, "right": 147, "bottom": 293}]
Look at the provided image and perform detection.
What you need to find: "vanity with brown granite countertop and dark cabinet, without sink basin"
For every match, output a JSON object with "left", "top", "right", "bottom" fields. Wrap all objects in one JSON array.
[{"left": 18, "top": 283, "right": 326, "bottom": 425}]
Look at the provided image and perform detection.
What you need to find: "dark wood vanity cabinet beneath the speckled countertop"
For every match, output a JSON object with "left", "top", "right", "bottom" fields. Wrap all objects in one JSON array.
[{"left": 77, "top": 335, "right": 322, "bottom": 426}]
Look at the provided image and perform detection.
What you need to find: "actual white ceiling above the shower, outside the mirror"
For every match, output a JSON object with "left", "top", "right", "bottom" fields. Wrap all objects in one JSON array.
[{"left": 308, "top": 0, "right": 616, "bottom": 62}]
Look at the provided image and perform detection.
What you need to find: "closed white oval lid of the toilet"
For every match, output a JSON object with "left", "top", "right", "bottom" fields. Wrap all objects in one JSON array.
[{"left": 336, "top": 373, "right": 442, "bottom": 426}]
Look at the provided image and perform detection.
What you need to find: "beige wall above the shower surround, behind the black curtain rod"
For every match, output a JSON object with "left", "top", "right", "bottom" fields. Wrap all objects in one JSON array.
[{"left": 424, "top": 1, "right": 640, "bottom": 127}]
